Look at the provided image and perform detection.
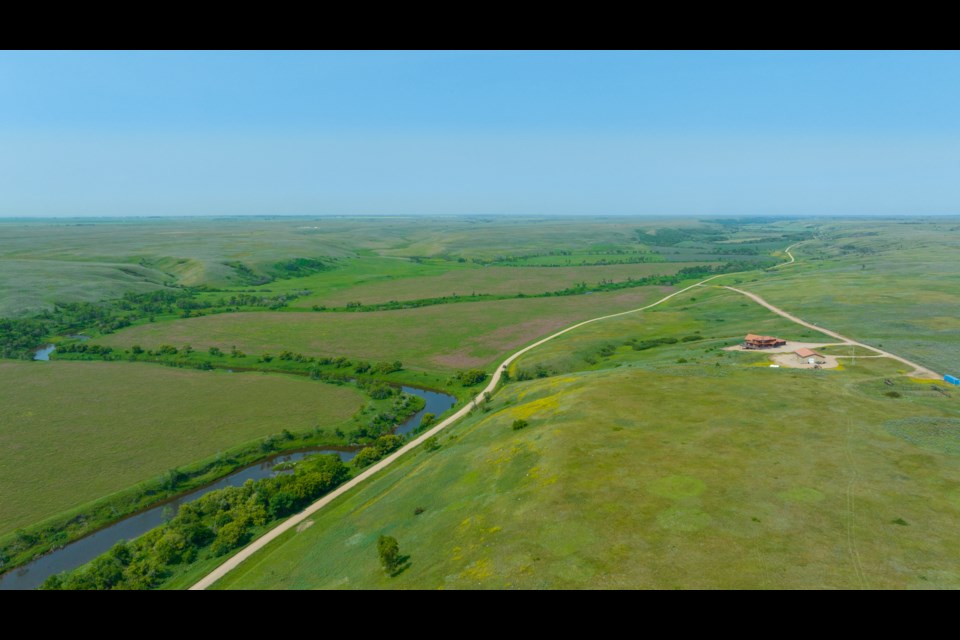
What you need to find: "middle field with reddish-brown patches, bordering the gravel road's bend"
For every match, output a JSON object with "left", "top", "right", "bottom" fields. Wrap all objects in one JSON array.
[{"left": 97, "top": 287, "right": 670, "bottom": 373}]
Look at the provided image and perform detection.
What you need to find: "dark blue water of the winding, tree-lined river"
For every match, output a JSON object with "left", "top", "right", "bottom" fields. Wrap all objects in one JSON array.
[{"left": 0, "top": 380, "right": 456, "bottom": 591}]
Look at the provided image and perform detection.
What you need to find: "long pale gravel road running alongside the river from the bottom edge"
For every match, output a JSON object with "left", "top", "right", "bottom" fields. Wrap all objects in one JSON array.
[{"left": 190, "top": 274, "right": 731, "bottom": 591}]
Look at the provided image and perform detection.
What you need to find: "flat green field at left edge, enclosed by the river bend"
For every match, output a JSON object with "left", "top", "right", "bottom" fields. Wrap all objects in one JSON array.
[{"left": 0, "top": 361, "right": 364, "bottom": 535}]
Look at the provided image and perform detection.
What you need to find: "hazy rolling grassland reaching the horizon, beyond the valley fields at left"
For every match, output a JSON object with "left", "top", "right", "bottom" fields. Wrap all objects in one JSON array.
[{"left": 0, "top": 217, "right": 804, "bottom": 317}]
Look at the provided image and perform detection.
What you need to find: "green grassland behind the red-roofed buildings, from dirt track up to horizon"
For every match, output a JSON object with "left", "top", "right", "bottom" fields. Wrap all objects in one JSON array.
[{"left": 721, "top": 218, "right": 960, "bottom": 374}]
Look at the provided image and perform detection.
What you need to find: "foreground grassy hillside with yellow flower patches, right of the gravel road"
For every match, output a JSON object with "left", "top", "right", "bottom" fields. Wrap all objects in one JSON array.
[{"left": 218, "top": 360, "right": 960, "bottom": 589}]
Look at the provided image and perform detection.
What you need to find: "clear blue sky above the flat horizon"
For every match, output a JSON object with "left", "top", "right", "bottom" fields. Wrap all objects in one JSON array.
[{"left": 0, "top": 52, "right": 960, "bottom": 216}]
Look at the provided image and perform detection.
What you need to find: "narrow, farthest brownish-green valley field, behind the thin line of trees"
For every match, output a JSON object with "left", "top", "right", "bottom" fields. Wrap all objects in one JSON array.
[{"left": 291, "top": 258, "right": 705, "bottom": 308}]
